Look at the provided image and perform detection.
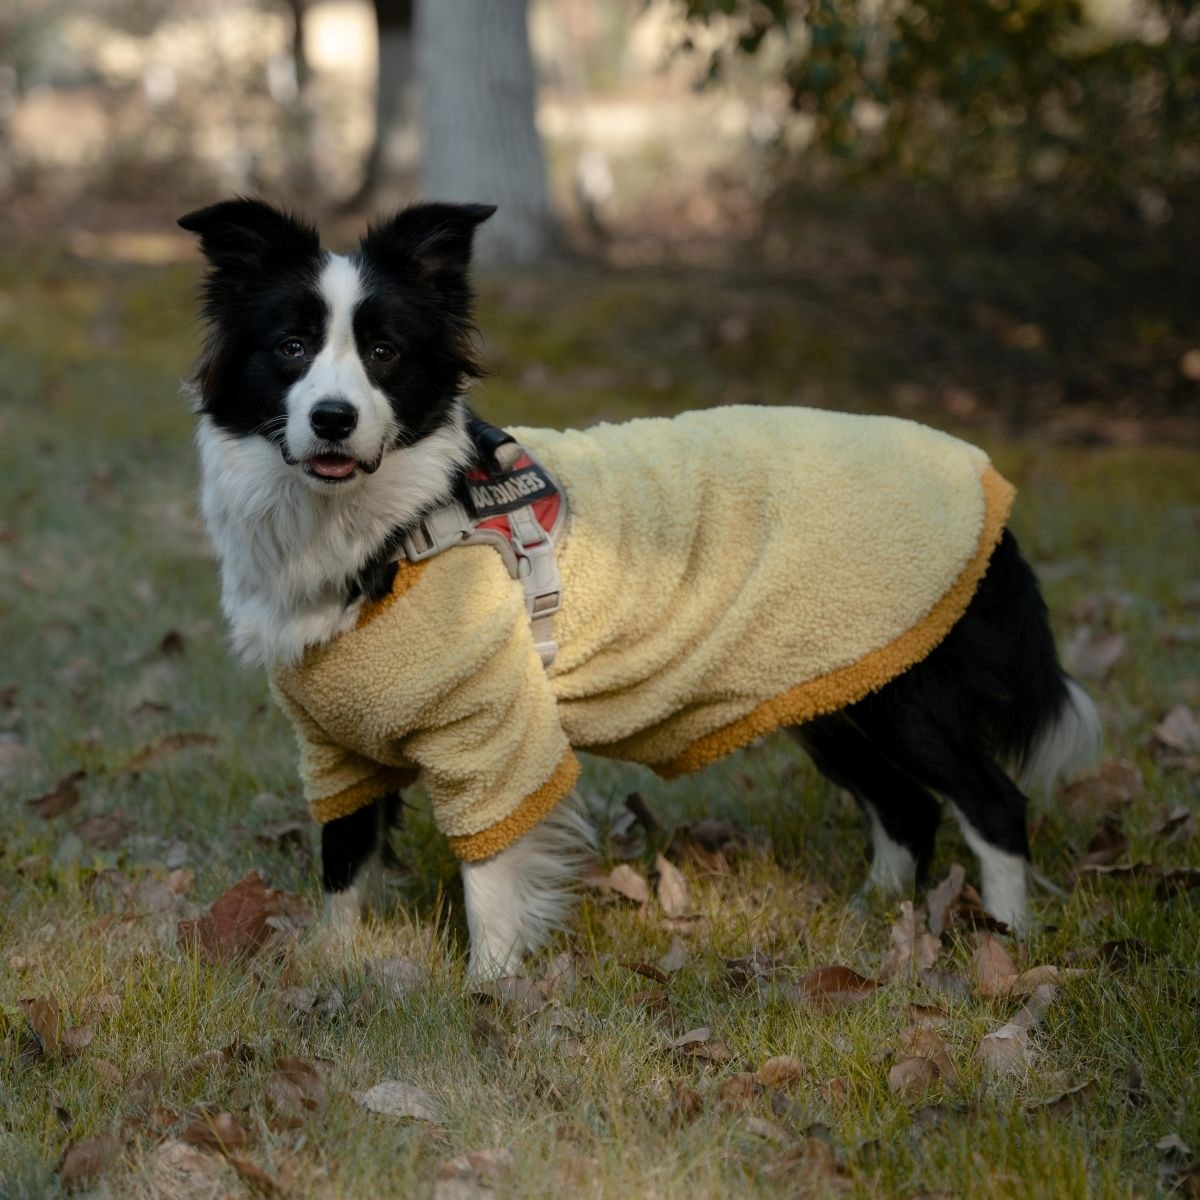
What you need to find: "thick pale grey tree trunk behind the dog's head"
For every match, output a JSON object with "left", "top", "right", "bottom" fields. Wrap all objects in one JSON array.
[{"left": 416, "top": 0, "right": 554, "bottom": 266}]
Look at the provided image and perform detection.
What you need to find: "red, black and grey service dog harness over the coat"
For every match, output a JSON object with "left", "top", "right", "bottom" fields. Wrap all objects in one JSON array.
[{"left": 400, "top": 418, "right": 566, "bottom": 667}]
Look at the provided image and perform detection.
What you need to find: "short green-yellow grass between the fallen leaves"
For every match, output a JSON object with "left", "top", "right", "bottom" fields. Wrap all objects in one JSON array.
[{"left": 0, "top": 246, "right": 1200, "bottom": 1198}]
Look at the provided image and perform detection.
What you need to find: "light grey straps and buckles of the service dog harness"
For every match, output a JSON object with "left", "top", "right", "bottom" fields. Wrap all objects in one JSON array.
[{"left": 401, "top": 442, "right": 566, "bottom": 667}]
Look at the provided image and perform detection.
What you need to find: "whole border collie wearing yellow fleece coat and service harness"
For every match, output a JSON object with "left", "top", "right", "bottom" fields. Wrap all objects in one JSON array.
[{"left": 179, "top": 198, "right": 1100, "bottom": 978}]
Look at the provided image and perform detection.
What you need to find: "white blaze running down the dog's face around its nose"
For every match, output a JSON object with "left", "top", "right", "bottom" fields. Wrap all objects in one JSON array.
[{"left": 280, "top": 254, "right": 396, "bottom": 462}]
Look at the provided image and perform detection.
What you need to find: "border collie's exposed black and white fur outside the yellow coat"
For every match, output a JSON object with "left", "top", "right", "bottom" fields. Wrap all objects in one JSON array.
[{"left": 180, "top": 199, "right": 1099, "bottom": 972}]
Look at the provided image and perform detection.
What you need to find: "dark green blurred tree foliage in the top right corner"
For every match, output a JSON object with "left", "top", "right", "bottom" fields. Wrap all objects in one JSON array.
[{"left": 679, "top": 0, "right": 1200, "bottom": 222}]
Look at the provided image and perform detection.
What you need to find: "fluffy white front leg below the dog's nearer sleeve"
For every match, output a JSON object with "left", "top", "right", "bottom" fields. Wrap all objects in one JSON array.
[{"left": 462, "top": 797, "right": 595, "bottom": 982}]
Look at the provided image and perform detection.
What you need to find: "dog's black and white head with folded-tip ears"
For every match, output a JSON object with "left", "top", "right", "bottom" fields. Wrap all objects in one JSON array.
[{"left": 179, "top": 198, "right": 494, "bottom": 491}]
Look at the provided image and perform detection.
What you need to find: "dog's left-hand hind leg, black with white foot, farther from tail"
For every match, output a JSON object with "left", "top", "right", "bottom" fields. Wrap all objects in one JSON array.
[{"left": 790, "top": 709, "right": 941, "bottom": 895}]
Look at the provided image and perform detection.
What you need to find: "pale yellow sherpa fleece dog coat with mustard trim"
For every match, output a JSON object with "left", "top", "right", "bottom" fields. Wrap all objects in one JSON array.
[{"left": 274, "top": 407, "right": 1013, "bottom": 859}]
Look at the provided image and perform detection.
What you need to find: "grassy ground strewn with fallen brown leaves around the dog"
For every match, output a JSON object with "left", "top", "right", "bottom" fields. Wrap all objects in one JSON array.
[{"left": 0, "top": 246, "right": 1200, "bottom": 1200}]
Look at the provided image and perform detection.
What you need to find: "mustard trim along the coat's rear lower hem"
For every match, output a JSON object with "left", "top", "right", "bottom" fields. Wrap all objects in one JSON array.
[{"left": 649, "top": 466, "right": 1016, "bottom": 779}]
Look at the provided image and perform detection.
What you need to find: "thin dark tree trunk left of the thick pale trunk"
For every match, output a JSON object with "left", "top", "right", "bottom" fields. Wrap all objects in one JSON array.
[{"left": 343, "top": 0, "right": 417, "bottom": 209}]
